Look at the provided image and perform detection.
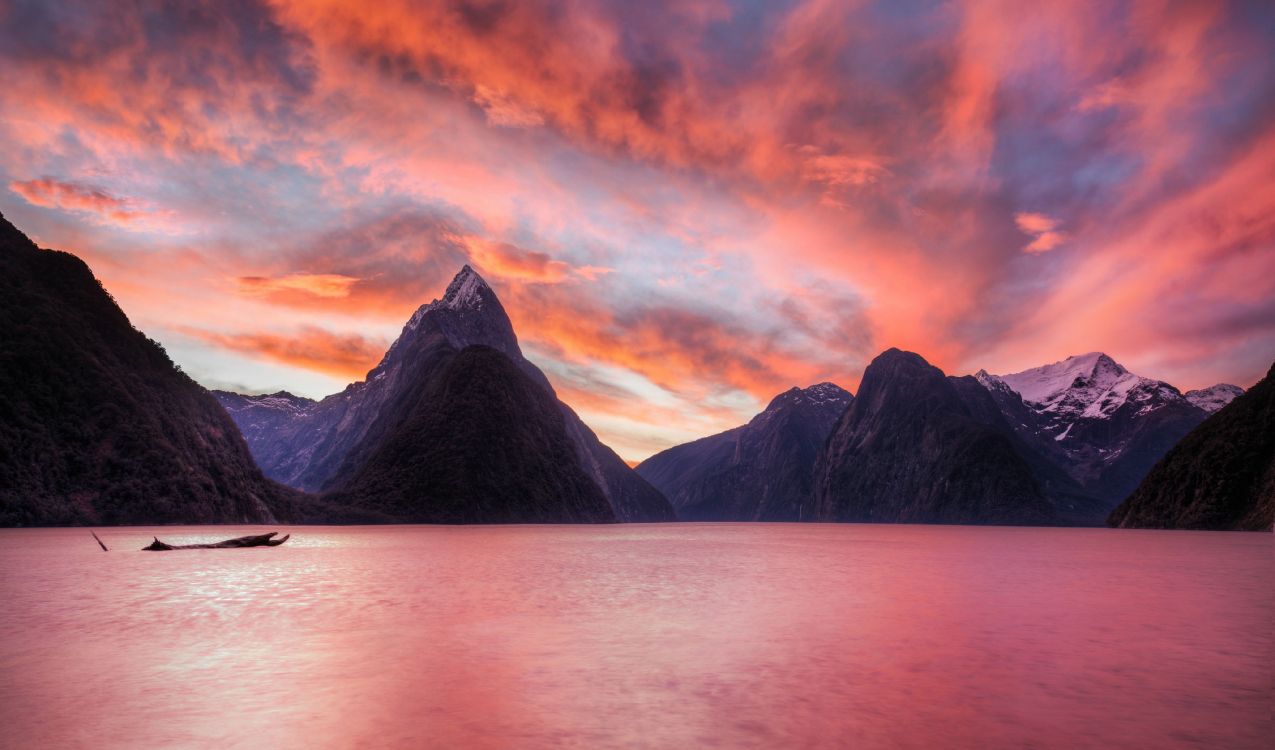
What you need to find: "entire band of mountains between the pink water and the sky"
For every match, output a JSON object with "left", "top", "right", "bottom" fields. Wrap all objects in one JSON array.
[{"left": 0, "top": 209, "right": 1275, "bottom": 531}]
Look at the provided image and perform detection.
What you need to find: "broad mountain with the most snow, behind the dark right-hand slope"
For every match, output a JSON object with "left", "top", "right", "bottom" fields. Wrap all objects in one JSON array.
[{"left": 975, "top": 352, "right": 1207, "bottom": 509}]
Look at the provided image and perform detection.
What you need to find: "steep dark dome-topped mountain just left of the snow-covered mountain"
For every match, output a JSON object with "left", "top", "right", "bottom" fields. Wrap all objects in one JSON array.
[{"left": 815, "top": 349, "right": 1057, "bottom": 524}]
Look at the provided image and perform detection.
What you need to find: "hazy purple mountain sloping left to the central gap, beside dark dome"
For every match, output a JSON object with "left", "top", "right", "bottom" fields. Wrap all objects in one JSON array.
[{"left": 638, "top": 383, "right": 854, "bottom": 520}]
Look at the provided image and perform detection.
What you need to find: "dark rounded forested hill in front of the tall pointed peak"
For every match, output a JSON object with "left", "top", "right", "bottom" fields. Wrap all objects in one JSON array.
[{"left": 330, "top": 342, "right": 615, "bottom": 523}]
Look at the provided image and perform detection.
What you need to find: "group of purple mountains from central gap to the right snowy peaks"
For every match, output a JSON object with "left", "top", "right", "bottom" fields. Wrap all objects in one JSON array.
[{"left": 638, "top": 349, "right": 1259, "bottom": 526}]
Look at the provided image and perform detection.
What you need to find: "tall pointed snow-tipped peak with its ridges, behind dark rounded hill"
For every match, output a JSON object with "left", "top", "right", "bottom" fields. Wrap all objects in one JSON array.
[{"left": 218, "top": 265, "right": 674, "bottom": 522}]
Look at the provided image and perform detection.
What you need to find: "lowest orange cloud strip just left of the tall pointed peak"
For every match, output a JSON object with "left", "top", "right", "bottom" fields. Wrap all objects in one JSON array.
[{"left": 177, "top": 327, "right": 388, "bottom": 380}]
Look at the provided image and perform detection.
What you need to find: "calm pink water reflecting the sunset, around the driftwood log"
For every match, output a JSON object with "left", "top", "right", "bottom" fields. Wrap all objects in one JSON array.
[{"left": 0, "top": 524, "right": 1275, "bottom": 749}]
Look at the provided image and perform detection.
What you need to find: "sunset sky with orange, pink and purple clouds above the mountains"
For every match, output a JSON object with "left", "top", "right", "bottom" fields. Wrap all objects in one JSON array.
[{"left": 0, "top": 0, "right": 1275, "bottom": 460}]
